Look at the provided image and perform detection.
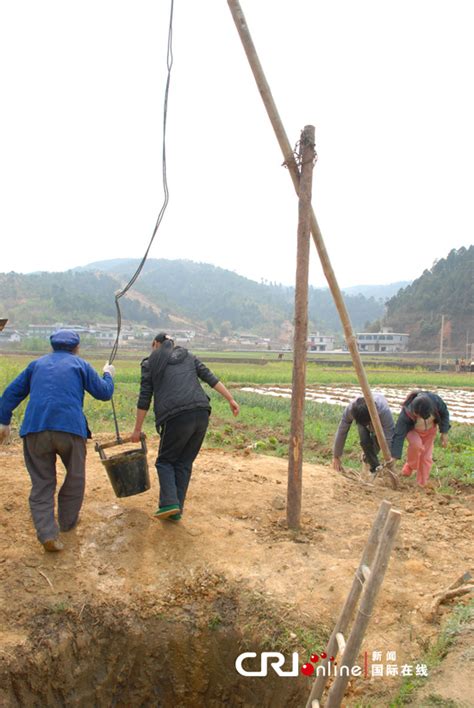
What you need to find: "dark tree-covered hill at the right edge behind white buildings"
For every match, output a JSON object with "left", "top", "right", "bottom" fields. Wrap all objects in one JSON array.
[{"left": 384, "top": 246, "right": 474, "bottom": 353}]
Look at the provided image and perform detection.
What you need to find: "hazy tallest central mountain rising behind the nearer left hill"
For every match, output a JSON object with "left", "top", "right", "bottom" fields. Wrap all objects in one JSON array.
[{"left": 76, "top": 259, "right": 384, "bottom": 336}]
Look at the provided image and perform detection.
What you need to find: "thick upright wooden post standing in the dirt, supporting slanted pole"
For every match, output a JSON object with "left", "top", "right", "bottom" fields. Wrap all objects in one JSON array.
[{"left": 286, "top": 125, "right": 316, "bottom": 529}]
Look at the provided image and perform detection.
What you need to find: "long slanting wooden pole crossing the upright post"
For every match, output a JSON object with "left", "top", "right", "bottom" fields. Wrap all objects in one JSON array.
[{"left": 227, "top": 0, "right": 392, "bottom": 482}]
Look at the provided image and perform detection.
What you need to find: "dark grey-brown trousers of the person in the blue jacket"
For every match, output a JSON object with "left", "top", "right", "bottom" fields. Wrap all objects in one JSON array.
[{"left": 23, "top": 430, "right": 86, "bottom": 543}]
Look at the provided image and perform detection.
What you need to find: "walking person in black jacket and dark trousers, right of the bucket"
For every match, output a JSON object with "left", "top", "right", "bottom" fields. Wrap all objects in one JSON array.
[{"left": 132, "top": 332, "right": 239, "bottom": 521}]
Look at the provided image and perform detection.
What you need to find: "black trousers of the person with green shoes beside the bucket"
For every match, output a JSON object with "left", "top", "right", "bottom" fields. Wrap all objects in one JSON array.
[{"left": 156, "top": 408, "right": 209, "bottom": 510}]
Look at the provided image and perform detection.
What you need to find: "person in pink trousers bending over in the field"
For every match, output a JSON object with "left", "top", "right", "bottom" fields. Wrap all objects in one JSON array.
[{"left": 392, "top": 391, "right": 451, "bottom": 487}]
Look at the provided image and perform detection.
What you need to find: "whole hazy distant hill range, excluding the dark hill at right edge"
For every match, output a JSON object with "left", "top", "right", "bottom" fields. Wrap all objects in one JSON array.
[{"left": 0, "top": 259, "right": 384, "bottom": 338}]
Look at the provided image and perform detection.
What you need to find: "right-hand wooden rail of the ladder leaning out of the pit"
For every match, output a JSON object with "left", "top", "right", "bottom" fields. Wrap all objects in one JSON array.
[{"left": 326, "top": 509, "right": 401, "bottom": 708}]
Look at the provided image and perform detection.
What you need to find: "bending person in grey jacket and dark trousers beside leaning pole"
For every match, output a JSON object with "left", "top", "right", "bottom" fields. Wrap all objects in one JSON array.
[{"left": 332, "top": 393, "right": 395, "bottom": 477}]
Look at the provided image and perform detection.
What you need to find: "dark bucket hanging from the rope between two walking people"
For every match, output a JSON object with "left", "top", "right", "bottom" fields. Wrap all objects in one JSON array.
[{"left": 95, "top": 434, "right": 150, "bottom": 497}]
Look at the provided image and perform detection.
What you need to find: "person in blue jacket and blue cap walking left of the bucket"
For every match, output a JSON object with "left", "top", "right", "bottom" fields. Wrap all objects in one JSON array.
[{"left": 0, "top": 329, "right": 115, "bottom": 551}]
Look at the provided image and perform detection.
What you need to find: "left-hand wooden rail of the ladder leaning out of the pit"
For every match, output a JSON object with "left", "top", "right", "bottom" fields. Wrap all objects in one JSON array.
[{"left": 306, "top": 501, "right": 392, "bottom": 708}]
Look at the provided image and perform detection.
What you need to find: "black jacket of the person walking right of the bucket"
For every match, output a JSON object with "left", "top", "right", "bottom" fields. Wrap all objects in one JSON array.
[{"left": 137, "top": 347, "right": 219, "bottom": 430}]
